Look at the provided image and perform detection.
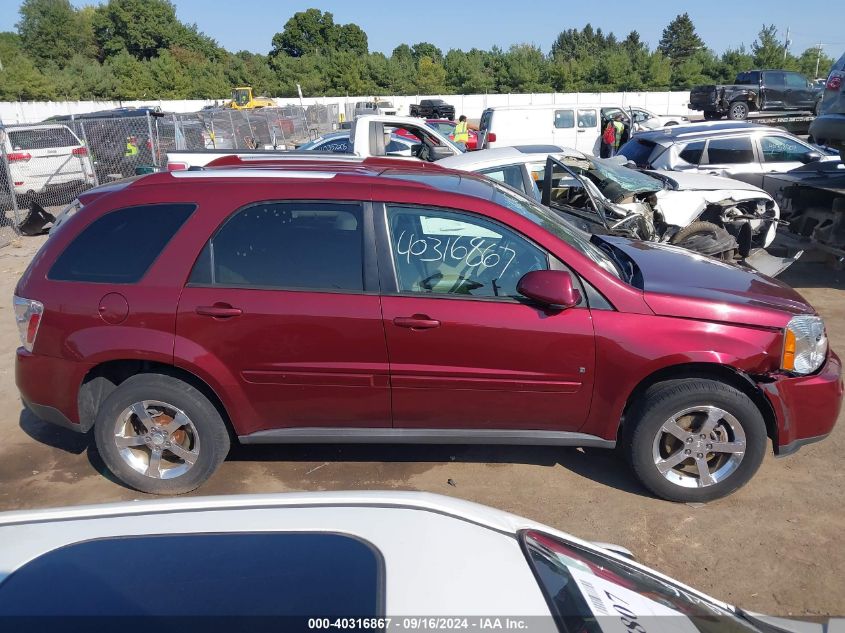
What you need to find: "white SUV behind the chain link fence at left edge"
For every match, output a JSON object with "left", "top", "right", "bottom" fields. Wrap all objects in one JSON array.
[{"left": 0, "top": 124, "right": 95, "bottom": 206}]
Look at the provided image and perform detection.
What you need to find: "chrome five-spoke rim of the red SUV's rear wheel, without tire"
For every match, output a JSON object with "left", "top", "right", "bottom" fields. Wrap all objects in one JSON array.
[{"left": 114, "top": 400, "right": 200, "bottom": 479}]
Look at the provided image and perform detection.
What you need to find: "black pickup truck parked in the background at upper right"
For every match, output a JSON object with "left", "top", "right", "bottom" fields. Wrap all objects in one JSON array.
[{"left": 689, "top": 70, "right": 822, "bottom": 121}]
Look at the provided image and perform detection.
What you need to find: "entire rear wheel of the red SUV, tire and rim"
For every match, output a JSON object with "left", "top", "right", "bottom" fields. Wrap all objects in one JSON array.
[{"left": 94, "top": 374, "right": 229, "bottom": 494}]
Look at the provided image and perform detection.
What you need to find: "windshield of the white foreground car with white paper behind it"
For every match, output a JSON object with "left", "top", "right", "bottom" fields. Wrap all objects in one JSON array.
[{"left": 521, "top": 531, "right": 758, "bottom": 633}]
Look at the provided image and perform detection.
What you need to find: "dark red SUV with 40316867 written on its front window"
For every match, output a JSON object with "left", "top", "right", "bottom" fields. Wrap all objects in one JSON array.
[{"left": 14, "top": 157, "right": 842, "bottom": 501}]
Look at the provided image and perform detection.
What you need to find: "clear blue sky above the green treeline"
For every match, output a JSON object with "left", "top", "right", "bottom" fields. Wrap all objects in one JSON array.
[{"left": 0, "top": 0, "right": 845, "bottom": 58}]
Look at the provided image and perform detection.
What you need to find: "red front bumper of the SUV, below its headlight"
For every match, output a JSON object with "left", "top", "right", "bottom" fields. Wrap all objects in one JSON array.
[{"left": 760, "top": 351, "right": 843, "bottom": 456}]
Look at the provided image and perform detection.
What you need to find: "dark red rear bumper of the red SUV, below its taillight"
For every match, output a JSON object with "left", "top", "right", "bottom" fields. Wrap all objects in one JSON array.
[{"left": 15, "top": 347, "right": 94, "bottom": 433}]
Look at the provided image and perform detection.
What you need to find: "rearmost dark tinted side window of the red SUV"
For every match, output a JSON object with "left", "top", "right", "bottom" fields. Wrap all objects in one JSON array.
[{"left": 47, "top": 204, "right": 196, "bottom": 284}]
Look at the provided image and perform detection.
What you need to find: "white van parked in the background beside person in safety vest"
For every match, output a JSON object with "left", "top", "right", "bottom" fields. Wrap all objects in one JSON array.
[{"left": 478, "top": 103, "right": 630, "bottom": 156}]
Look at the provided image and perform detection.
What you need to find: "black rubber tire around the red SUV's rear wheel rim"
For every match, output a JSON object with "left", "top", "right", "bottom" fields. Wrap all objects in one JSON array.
[{"left": 94, "top": 374, "right": 230, "bottom": 495}]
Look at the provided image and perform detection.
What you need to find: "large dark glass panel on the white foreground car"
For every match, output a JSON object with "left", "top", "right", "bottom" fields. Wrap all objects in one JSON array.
[{"left": 0, "top": 532, "right": 385, "bottom": 616}]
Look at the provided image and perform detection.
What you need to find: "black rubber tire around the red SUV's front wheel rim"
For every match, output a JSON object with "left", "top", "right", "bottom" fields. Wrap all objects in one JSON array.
[{"left": 623, "top": 378, "right": 767, "bottom": 503}]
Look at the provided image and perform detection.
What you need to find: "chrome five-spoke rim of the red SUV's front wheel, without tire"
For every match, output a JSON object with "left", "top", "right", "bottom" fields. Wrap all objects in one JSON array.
[{"left": 652, "top": 406, "right": 745, "bottom": 488}]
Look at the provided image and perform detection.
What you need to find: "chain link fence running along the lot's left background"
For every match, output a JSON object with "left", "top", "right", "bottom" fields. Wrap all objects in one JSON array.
[{"left": 0, "top": 104, "right": 339, "bottom": 246}]
